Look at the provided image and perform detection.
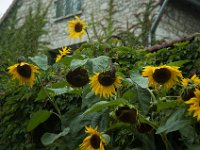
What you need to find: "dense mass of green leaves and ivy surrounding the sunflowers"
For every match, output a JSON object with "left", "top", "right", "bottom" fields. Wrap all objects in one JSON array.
[{"left": 0, "top": 0, "right": 200, "bottom": 150}]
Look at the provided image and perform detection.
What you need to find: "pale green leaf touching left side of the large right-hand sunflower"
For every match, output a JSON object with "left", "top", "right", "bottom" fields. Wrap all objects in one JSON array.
[{"left": 130, "top": 72, "right": 148, "bottom": 88}]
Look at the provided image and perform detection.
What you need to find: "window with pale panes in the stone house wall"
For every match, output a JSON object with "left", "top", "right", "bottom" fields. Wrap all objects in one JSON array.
[{"left": 55, "top": 0, "right": 81, "bottom": 18}]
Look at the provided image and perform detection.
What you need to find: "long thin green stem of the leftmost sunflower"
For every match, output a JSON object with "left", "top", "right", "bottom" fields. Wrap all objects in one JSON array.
[{"left": 37, "top": 76, "right": 62, "bottom": 120}]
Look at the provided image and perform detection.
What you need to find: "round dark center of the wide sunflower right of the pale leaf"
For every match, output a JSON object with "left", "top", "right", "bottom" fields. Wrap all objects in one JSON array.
[{"left": 153, "top": 68, "right": 171, "bottom": 84}]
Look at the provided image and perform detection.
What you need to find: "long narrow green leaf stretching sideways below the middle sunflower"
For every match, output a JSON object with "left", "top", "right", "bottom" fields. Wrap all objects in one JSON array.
[{"left": 84, "top": 98, "right": 128, "bottom": 114}]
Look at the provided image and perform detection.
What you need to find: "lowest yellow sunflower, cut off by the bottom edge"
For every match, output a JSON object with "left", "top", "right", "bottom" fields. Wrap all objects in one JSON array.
[{"left": 80, "top": 127, "right": 106, "bottom": 150}]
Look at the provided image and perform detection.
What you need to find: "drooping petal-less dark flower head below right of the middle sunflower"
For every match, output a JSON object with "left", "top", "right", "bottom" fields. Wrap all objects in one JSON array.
[{"left": 115, "top": 106, "right": 138, "bottom": 123}]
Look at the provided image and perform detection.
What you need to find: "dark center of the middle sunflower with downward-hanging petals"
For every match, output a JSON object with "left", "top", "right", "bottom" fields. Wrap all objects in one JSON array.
[{"left": 98, "top": 71, "right": 115, "bottom": 86}]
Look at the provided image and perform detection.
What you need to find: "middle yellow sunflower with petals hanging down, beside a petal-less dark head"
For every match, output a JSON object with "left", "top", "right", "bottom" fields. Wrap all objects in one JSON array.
[{"left": 90, "top": 71, "right": 121, "bottom": 97}]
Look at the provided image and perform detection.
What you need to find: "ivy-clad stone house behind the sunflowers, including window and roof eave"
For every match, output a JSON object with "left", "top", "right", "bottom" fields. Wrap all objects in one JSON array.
[{"left": 0, "top": 0, "right": 200, "bottom": 50}]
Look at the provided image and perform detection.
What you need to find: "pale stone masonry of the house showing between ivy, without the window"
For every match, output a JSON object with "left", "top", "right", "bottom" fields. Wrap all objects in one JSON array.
[{"left": 13, "top": 0, "right": 199, "bottom": 49}]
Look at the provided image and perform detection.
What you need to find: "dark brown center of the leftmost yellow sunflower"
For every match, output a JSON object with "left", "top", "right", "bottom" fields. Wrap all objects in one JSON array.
[{"left": 17, "top": 64, "right": 31, "bottom": 78}]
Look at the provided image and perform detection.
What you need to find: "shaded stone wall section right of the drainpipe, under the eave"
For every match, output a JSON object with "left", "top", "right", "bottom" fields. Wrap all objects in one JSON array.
[{"left": 157, "top": 2, "right": 200, "bottom": 39}]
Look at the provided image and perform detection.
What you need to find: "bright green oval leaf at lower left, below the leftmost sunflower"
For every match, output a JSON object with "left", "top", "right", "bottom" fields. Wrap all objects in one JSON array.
[{"left": 27, "top": 110, "right": 51, "bottom": 131}]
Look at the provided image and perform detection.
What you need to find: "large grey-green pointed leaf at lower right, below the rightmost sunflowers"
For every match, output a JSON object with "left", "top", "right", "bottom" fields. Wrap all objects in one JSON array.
[{"left": 156, "top": 108, "right": 191, "bottom": 134}]
